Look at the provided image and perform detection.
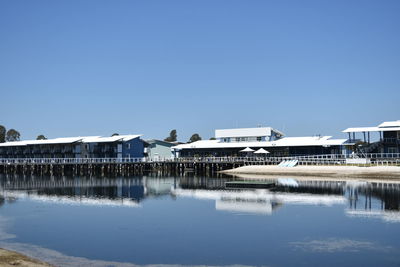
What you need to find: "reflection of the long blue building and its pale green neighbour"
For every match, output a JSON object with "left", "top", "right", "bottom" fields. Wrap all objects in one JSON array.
[{"left": 0, "top": 176, "right": 177, "bottom": 204}]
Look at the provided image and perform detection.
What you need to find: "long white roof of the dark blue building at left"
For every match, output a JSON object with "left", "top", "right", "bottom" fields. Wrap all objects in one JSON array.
[{"left": 0, "top": 135, "right": 141, "bottom": 147}]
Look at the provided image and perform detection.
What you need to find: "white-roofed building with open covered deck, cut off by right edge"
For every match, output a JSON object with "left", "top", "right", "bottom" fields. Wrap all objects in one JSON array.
[{"left": 343, "top": 120, "right": 400, "bottom": 153}]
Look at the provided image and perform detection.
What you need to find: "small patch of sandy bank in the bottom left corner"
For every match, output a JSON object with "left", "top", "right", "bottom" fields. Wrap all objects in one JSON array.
[{"left": 0, "top": 248, "right": 52, "bottom": 267}]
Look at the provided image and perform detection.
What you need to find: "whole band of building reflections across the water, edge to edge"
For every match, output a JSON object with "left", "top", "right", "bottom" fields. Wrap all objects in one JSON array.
[{"left": 0, "top": 175, "right": 400, "bottom": 222}]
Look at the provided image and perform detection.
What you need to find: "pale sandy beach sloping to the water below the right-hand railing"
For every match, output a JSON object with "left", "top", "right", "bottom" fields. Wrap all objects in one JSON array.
[{"left": 222, "top": 165, "right": 400, "bottom": 179}]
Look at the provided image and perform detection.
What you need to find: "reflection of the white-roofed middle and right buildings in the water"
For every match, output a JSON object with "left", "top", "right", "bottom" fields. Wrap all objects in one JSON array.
[{"left": 174, "top": 177, "right": 400, "bottom": 218}]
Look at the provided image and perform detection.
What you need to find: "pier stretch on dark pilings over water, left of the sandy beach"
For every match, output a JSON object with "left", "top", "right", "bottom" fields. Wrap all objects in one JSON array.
[{"left": 0, "top": 158, "right": 250, "bottom": 176}]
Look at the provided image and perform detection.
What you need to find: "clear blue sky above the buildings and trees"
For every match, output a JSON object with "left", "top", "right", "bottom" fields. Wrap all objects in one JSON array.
[{"left": 0, "top": 0, "right": 400, "bottom": 141}]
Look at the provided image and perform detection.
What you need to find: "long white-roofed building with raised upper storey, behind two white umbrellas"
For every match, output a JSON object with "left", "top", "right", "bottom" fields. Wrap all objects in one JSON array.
[{"left": 172, "top": 127, "right": 348, "bottom": 157}]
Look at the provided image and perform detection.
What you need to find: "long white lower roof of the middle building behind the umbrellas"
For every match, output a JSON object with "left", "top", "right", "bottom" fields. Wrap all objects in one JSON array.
[{"left": 172, "top": 136, "right": 347, "bottom": 150}]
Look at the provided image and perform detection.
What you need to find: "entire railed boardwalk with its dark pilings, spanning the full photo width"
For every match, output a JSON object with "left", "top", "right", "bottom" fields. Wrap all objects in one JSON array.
[{"left": 0, "top": 153, "right": 400, "bottom": 178}]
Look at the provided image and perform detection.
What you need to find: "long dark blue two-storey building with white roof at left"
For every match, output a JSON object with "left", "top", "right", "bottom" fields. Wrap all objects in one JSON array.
[{"left": 0, "top": 135, "right": 144, "bottom": 158}]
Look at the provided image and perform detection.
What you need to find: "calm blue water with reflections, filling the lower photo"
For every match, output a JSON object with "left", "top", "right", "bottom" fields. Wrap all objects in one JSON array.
[{"left": 0, "top": 175, "right": 400, "bottom": 266}]
